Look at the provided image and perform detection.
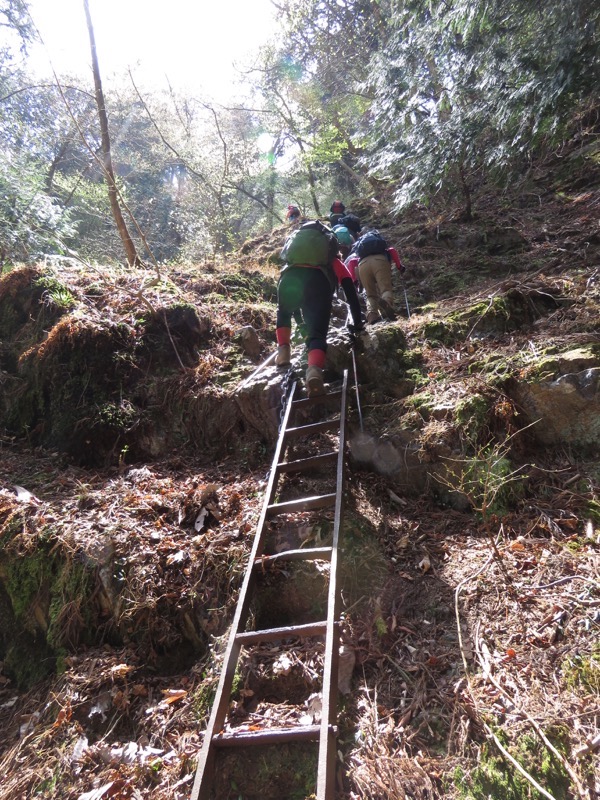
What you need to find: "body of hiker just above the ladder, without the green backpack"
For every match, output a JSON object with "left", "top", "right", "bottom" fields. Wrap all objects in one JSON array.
[{"left": 275, "top": 222, "right": 364, "bottom": 397}]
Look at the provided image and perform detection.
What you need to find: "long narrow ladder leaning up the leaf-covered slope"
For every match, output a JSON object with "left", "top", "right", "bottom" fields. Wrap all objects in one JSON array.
[{"left": 191, "top": 371, "right": 348, "bottom": 800}]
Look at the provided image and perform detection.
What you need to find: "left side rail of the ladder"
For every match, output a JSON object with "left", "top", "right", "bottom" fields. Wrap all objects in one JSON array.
[{"left": 190, "top": 381, "right": 298, "bottom": 800}]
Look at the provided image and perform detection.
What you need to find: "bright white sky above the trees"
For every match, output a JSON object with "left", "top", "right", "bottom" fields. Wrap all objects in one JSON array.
[{"left": 22, "top": 0, "right": 277, "bottom": 101}]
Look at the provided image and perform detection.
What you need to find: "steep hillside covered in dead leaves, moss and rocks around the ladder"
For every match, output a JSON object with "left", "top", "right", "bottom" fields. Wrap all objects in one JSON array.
[{"left": 0, "top": 133, "right": 600, "bottom": 800}]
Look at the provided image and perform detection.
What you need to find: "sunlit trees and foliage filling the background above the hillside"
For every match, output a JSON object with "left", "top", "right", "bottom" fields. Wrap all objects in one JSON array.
[{"left": 0, "top": 0, "right": 600, "bottom": 260}]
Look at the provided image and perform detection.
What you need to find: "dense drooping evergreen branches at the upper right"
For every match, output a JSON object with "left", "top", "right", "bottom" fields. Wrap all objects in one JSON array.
[{"left": 368, "top": 0, "right": 600, "bottom": 213}]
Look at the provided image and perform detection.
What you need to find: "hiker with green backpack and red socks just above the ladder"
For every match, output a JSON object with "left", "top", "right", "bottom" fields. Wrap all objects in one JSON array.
[{"left": 275, "top": 221, "right": 363, "bottom": 397}]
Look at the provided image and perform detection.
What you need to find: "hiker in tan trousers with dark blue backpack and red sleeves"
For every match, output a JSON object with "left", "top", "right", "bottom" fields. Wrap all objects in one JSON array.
[{"left": 346, "top": 231, "right": 405, "bottom": 325}]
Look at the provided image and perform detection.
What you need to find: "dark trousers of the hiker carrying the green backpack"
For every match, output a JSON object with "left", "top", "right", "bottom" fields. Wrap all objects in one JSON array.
[{"left": 277, "top": 267, "right": 333, "bottom": 351}]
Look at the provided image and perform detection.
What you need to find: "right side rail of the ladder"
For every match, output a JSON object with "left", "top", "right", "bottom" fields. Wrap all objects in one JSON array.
[{"left": 317, "top": 370, "right": 348, "bottom": 800}]
